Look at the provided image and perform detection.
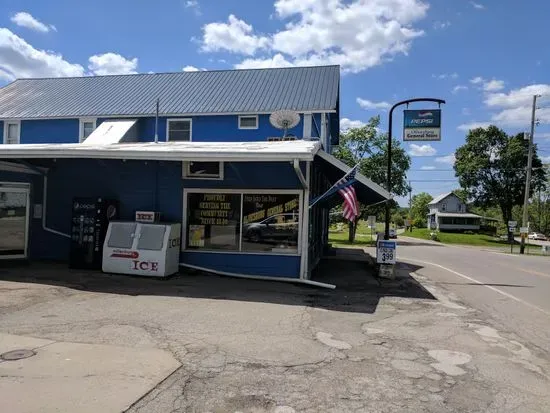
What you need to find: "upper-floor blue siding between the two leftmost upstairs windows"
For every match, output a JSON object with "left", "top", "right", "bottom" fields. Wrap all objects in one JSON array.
[{"left": 20, "top": 119, "right": 79, "bottom": 143}]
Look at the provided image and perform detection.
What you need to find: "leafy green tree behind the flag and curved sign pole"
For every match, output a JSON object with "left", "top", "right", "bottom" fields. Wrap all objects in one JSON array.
[{"left": 333, "top": 116, "right": 411, "bottom": 242}]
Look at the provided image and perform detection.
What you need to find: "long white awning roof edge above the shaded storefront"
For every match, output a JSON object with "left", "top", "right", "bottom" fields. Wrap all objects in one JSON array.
[{"left": 0, "top": 140, "right": 321, "bottom": 162}]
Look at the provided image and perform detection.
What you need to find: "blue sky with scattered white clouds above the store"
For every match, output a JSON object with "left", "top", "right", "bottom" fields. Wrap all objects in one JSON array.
[{"left": 0, "top": 0, "right": 550, "bottom": 204}]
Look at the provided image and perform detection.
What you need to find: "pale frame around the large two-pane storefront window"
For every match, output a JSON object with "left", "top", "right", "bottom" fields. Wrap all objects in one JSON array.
[{"left": 181, "top": 188, "right": 304, "bottom": 257}]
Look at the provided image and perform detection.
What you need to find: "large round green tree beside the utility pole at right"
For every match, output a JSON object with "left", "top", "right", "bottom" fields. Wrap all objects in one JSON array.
[{"left": 454, "top": 126, "right": 545, "bottom": 222}]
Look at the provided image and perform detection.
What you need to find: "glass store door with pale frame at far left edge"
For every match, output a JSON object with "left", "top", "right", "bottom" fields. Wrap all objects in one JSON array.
[{"left": 0, "top": 184, "right": 30, "bottom": 259}]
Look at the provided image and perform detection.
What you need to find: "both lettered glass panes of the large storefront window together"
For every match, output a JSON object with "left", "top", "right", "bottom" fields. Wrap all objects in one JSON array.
[{"left": 185, "top": 192, "right": 300, "bottom": 254}]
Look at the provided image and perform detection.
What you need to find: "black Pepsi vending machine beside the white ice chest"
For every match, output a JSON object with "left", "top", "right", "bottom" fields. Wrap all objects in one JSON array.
[{"left": 69, "top": 198, "right": 119, "bottom": 270}]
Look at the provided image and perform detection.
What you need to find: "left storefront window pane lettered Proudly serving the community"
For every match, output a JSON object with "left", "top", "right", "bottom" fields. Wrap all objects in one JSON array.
[{"left": 186, "top": 193, "right": 241, "bottom": 251}]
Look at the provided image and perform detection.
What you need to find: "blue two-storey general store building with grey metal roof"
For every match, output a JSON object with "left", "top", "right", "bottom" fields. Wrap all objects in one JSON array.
[{"left": 0, "top": 66, "right": 389, "bottom": 280}]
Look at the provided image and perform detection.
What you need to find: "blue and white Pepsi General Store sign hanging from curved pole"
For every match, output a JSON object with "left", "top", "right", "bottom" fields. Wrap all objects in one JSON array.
[{"left": 403, "top": 109, "right": 441, "bottom": 141}]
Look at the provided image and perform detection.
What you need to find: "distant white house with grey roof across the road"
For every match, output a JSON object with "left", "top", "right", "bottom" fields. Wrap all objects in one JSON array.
[{"left": 428, "top": 192, "right": 482, "bottom": 231}]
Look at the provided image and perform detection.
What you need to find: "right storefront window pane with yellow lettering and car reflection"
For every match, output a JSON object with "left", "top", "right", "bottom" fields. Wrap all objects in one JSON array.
[{"left": 242, "top": 194, "right": 300, "bottom": 252}]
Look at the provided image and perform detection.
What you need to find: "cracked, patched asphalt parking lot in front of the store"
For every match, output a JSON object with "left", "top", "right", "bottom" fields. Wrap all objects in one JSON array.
[{"left": 0, "top": 254, "right": 550, "bottom": 413}]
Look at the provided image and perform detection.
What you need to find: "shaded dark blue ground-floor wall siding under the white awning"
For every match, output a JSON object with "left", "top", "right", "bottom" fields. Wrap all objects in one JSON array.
[{"left": 0, "top": 159, "right": 300, "bottom": 277}]
